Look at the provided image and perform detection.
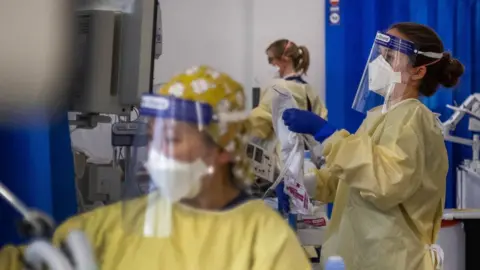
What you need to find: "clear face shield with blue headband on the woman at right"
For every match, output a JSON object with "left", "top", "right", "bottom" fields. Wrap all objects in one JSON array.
[{"left": 352, "top": 32, "right": 442, "bottom": 113}]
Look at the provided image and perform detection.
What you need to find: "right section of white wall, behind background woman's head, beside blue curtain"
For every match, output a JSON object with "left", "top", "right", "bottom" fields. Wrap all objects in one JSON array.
[{"left": 253, "top": 0, "right": 325, "bottom": 100}]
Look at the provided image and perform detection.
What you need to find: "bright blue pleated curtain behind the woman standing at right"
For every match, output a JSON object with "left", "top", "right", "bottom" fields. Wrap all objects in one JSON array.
[{"left": 325, "top": 0, "right": 480, "bottom": 208}]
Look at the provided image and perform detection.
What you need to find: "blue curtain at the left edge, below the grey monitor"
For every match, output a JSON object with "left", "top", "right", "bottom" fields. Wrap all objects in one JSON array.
[{"left": 0, "top": 112, "right": 77, "bottom": 247}]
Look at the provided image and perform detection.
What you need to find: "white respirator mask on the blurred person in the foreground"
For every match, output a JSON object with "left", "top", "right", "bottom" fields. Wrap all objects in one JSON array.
[{"left": 145, "top": 148, "right": 209, "bottom": 203}]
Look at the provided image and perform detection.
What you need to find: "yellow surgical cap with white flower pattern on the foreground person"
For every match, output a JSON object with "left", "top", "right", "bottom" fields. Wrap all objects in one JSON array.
[{"left": 156, "top": 66, "right": 253, "bottom": 185}]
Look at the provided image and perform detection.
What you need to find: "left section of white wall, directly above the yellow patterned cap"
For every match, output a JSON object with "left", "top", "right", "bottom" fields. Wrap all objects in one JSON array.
[{"left": 154, "top": 0, "right": 248, "bottom": 93}]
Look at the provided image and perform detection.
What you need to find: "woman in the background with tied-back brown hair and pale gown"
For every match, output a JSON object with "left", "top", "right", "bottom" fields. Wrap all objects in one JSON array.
[{"left": 249, "top": 39, "right": 327, "bottom": 140}]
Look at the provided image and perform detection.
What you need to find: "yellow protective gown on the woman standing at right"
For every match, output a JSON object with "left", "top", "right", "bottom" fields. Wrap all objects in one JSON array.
[{"left": 317, "top": 99, "right": 448, "bottom": 270}]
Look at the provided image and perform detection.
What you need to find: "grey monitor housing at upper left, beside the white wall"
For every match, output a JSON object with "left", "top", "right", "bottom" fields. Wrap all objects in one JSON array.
[{"left": 69, "top": 0, "right": 162, "bottom": 115}]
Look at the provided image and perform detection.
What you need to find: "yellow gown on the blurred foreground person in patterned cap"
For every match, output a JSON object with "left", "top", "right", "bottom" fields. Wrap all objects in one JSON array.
[{"left": 0, "top": 197, "right": 311, "bottom": 270}]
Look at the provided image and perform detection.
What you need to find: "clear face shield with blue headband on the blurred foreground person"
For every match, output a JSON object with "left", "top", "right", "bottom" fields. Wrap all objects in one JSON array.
[{"left": 122, "top": 95, "right": 218, "bottom": 237}]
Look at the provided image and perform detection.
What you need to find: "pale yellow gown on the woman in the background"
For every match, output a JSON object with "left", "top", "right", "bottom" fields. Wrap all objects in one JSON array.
[{"left": 249, "top": 76, "right": 328, "bottom": 167}]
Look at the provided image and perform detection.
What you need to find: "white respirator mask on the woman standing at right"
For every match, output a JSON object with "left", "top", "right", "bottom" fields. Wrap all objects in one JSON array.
[{"left": 368, "top": 55, "right": 402, "bottom": 97}]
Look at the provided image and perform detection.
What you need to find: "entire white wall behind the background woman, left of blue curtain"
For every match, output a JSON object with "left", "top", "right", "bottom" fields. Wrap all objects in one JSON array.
[{"left": 155, "top": 0, "right": 325, "bottom": 107}]
